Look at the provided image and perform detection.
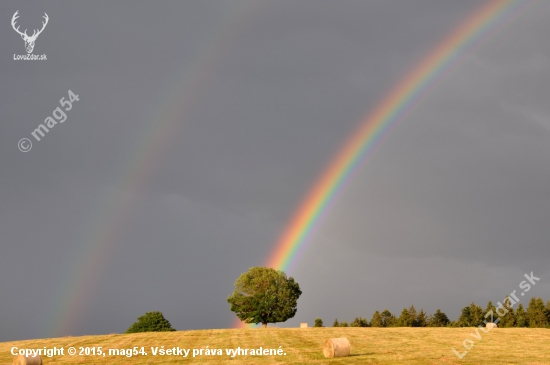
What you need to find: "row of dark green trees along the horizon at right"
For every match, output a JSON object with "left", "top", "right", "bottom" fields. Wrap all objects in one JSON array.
[{"left": 314, "top": 297, "right": 550, "bottom": 328}]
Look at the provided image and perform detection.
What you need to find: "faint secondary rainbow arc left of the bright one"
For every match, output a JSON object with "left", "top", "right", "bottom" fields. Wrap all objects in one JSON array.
[{"left": 41, "top": 2, "right": 264, "bottom": 338}]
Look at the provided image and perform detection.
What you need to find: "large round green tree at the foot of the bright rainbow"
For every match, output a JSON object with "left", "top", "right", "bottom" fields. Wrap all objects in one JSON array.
[{"left": 227, "top": 267, "right": 302, "bottom": 328}]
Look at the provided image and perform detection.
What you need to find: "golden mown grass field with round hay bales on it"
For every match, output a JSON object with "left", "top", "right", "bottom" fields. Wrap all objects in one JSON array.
[{"left": 0, "top": 327, "right": 550, "bottom": 365}]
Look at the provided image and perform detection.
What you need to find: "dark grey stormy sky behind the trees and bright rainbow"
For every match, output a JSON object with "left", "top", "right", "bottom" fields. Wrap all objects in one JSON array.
[{"left": 0, "top": 0, "right": 550, "bottom": 341}]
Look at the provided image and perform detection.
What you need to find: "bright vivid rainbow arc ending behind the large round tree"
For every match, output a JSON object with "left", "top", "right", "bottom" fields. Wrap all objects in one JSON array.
[{"left": 234, "top": 0, "right": 533, "bottom": 327}]
